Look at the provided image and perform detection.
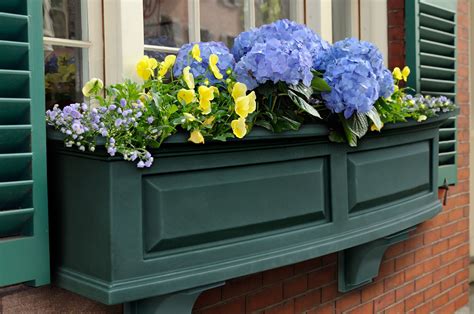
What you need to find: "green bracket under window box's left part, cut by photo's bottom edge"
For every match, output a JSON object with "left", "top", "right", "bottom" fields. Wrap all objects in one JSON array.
[{"left": 124, "top": 282, "right": 225, "bottom": 314}]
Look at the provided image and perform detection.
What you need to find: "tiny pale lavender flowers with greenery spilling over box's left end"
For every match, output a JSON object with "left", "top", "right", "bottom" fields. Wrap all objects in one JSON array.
[{"left": 46, "top": 99, "right": 159, "bottom": 168}]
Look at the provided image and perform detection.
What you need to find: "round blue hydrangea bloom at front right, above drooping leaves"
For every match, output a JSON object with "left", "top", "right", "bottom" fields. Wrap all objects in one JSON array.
[{"left": 321, "top": 57, "right": 379, "bottom": 119}]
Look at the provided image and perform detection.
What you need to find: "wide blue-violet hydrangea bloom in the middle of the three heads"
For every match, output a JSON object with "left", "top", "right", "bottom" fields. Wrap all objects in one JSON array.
[{"left": 234, "top": 39, "right": 313, "bottom": 89}]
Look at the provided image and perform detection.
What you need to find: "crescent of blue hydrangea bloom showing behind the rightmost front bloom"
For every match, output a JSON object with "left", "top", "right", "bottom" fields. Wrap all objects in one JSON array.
[{"left": 321, "top": 38, "right": 394, "bottom": 97}]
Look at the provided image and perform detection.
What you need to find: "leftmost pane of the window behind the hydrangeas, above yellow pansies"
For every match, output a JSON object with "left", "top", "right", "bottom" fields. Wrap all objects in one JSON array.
[{"left": 143, "top": 0, "right": 189, "bottom": 47}]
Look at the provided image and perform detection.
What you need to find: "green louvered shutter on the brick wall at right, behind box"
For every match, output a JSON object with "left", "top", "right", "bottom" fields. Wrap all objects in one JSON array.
[{"left": 405, "top": 0, "right": 457, "bottom": 186}]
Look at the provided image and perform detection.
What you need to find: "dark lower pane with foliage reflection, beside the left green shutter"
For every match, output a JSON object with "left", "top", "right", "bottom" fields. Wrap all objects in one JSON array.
[{"left": 44, "top": 46, "right": 83, "bottom": 109}]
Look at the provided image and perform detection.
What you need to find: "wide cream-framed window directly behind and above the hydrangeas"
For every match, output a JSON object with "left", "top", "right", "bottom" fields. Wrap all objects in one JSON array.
[{"left": 143, "top": 0, "right": 304, "bottom": 60}]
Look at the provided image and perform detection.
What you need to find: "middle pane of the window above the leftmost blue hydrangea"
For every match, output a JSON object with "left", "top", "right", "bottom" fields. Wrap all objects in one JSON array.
[{"left": 199, "top": 0, "right": 245, "bottom": 47}]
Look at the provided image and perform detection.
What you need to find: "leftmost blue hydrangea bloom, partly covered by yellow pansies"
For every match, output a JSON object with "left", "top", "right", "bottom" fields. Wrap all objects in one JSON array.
[{"left": 173, "top": 41, "right": 235, "bottom": 84}]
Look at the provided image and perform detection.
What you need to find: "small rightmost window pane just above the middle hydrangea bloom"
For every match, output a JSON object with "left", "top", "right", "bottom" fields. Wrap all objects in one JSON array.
[{"left": 255, "top": 0, "right": 291, "bottom": 26}]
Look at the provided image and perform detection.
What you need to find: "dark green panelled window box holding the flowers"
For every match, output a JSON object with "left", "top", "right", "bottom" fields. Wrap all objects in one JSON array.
[{"left": 48, "top": 114, "right": 454, "bottom": 304}]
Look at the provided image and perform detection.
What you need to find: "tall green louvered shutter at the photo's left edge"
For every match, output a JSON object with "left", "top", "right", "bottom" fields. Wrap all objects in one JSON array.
[{"left": 0, "top": 0, "right": 49, "bottom": 286}]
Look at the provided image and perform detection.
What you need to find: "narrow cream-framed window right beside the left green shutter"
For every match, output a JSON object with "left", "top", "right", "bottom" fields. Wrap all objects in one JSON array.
[{"left": 43, "top": 0, "right": 103, "bottom": 108}]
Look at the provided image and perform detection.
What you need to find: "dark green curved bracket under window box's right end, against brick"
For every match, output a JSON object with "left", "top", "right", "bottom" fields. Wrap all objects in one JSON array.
[{"left": 338, "top": 228, "right": 415, "bottom": 292}]
